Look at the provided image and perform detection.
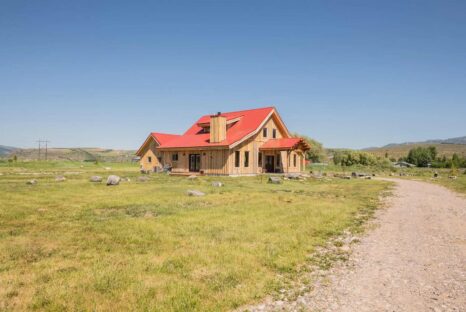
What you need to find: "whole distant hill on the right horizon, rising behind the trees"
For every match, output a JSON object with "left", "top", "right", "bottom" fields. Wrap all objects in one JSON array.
[{"left": 364, "top": 136, "right": 466, "bottom": 159}]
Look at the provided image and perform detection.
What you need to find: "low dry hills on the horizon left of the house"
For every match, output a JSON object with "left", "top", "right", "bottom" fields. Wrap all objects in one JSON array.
[{"left": 0, "top": 147, "right": 135, "bottom": 162}]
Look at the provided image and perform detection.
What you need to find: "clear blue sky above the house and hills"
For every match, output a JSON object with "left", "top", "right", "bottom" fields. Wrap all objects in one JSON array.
[{"left": 0, "top": 0, "right": 466, "bottom": 148}]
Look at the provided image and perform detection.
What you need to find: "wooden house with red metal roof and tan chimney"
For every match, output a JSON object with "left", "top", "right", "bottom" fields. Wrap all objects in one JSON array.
[{"left": 136, "top": 107, "right": 310, "bottom": 175}]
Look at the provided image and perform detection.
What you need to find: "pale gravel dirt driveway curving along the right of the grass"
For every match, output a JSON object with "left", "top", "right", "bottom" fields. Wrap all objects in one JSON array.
[{"left": 248, "top": 179, "right": 466, "bottom": 311}]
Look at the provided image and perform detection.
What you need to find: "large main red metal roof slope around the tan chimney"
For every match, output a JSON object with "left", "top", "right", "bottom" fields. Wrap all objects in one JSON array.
[{"left": 156, "top": 107, "right": 274, "bottom": 149}]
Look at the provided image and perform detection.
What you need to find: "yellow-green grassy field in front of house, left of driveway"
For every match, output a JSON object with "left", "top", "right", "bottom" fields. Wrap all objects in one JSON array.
[{"left": 0, "top": 162, "right": 390, "bottom": 311}]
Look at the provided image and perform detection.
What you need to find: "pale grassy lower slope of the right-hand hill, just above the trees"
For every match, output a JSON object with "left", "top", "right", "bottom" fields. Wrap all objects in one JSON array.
[{"left": 365, "top": 144, "right": 466, "bottom": 159}]
